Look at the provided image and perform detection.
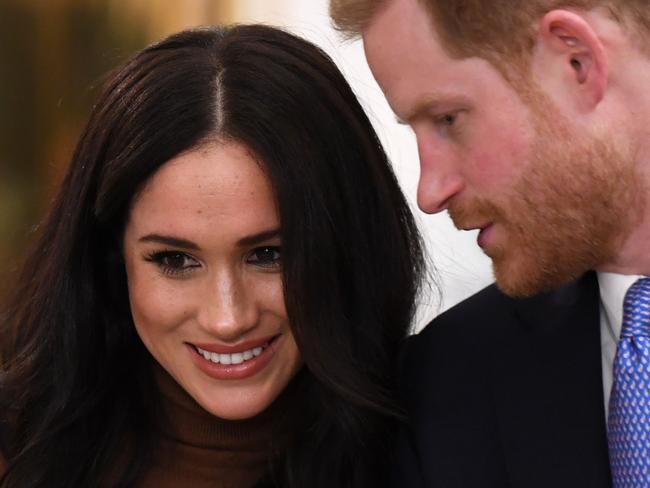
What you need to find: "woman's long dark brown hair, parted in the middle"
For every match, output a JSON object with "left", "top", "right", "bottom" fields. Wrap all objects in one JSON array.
[{"left": 0, "top": 26, "right": 423, "bottom": 488}]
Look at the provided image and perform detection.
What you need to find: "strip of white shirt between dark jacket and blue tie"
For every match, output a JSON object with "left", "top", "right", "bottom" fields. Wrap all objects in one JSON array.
[{"left": 598, "top": 273, "right": 642, "bottom": 419}]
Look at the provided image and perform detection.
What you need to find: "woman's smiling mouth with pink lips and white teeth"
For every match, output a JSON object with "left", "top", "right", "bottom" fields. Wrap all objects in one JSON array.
[{"left": 187, "top": 335, "right": 283, "bottom": 380}]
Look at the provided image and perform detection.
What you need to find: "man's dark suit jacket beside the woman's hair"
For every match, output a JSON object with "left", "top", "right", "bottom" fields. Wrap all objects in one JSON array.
[{"left": 394, "top": 273, "right": 611, "bottom": 488}]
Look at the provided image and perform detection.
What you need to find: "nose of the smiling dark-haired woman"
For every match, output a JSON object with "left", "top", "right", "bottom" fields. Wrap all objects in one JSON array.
[{"left": 199, "top": 270, "right": 258, "bottom": 342}]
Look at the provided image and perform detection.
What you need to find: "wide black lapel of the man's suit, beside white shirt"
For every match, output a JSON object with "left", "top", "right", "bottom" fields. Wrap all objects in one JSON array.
[{"left": 492, "top": 273, "right": 611, "bottom": 488}]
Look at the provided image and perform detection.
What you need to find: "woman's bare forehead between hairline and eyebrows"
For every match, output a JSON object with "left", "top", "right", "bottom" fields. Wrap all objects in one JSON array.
[{"left": 129, "top": 143, "right": 278, "bottom": 240}]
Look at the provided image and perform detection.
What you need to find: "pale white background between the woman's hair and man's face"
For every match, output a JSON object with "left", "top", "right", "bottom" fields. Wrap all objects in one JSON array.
[{"left": 232, "top": 0, "right": 493, "bottom": 328}]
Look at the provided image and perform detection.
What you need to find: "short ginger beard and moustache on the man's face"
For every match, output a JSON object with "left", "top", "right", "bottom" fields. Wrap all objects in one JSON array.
[{"left": 449, "top": 98, "right": 645, "bottom": 297}]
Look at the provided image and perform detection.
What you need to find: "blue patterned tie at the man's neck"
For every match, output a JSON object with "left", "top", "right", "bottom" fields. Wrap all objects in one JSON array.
[{"left": 608, "top": 278, "right": 650, "bottom": 488}]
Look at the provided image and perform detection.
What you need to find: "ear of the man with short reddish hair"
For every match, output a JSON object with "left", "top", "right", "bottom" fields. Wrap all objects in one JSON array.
[{"left": 532, "top": 10, "right": 608, "bottom": 110}]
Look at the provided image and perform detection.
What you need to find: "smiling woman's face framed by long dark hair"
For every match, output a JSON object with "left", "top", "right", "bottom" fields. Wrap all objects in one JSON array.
[{"left": 124, "top": 143, "right": 301, "bottom": 419}]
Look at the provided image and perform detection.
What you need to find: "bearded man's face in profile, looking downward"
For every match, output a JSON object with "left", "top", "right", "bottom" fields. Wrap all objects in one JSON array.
[{"left": 363, "top": 0, "right": 641, "bottom": 296}]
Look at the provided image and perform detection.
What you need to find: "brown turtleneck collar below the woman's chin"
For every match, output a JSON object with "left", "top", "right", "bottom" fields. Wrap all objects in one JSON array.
[{"left": 139, "top": 366, "right": 291, "bottom": 488}]
